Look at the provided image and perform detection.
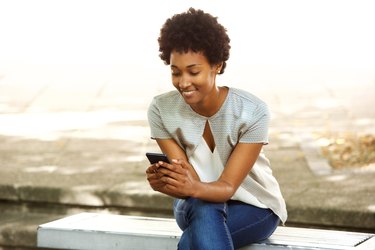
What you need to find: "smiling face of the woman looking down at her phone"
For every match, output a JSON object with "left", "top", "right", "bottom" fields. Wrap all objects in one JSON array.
[{"left": 170, "top": 51, "right": 218, "bottom": 107}]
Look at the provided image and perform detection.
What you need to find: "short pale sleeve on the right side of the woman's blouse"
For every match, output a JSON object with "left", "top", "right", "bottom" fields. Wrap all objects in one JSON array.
[{"left": 239, "top": 103, "right": 270, "bottom": 144}]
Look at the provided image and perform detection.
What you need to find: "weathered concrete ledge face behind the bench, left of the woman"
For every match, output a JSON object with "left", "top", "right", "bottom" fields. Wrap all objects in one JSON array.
[{"left": 0, "top": 182, "right": 173, "bottom": 210}]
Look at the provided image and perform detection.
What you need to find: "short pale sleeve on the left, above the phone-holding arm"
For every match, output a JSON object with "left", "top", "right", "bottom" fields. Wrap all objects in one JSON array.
[{"left": 147, "top": 98, "right": 172, "bottom": 139}]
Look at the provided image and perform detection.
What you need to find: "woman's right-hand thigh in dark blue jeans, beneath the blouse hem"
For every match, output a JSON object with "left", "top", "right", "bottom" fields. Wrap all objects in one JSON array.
[{"left": 227, "top": 200, "right": 280, "bottom": 248}]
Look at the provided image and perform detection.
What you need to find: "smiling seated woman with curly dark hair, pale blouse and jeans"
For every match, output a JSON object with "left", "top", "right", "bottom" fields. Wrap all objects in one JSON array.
[{"left": 146, "top": 8, "right": 287, "bottom": 250}]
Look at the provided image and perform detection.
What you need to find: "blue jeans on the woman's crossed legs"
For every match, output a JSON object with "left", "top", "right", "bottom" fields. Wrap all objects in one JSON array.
[{"left": 173, "top": 198, "right": 280, "bottom": 250}]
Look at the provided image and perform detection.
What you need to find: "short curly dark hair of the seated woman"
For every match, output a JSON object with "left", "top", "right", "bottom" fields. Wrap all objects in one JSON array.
[{"left": 158, "top": 8, "right": 230, "bottom": 74}]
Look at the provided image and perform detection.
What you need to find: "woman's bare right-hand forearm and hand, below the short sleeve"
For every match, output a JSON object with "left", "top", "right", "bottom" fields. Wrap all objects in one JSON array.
[{"left": 162, "top": 143, "right": 263, "bottom": 202}]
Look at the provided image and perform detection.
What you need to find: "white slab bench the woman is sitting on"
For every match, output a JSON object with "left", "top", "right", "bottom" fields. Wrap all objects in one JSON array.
[{"left": 37, "top": 213, "right": 375, "bottom": 250}]
